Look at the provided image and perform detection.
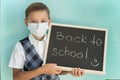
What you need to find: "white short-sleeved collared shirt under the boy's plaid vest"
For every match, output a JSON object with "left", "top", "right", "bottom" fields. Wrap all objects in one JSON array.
[{"left": 9, "top": 34, "right": 46, "bottom": 69}]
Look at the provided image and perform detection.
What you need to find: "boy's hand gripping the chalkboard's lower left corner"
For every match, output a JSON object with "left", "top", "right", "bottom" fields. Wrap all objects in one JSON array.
[{"left": 40, "top": 63, "right": 63, "bottom": 74}]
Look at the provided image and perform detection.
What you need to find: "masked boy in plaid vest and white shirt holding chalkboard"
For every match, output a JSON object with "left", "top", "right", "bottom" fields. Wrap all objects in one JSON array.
[{"left": 9, "top": 2, "right": 83, "bottom": 80}]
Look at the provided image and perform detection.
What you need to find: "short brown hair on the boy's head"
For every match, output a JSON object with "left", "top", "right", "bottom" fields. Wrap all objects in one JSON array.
[{"left": 25, "top": 2, "right": 50, "bottom": 19}]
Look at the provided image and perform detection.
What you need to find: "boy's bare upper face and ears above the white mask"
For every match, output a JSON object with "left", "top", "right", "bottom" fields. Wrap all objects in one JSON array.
[{"left": 25, "top": 10, "right": 50, "bottom": 26}]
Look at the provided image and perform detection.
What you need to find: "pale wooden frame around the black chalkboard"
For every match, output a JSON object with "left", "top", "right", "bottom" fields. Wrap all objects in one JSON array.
[{"left": 43, "top": 23, "right": 108, "bottom": 75}]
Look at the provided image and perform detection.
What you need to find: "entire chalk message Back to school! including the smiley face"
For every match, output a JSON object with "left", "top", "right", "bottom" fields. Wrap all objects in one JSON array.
[{"left": 48, "top": 31, "right": 103, "bottom": 67}]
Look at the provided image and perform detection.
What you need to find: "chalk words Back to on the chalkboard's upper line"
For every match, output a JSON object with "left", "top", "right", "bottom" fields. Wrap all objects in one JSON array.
[{"left": 56, "top": 32, "right": 103, "bottom": 46}]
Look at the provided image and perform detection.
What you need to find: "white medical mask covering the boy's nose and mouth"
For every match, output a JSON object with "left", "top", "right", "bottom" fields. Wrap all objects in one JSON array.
[{"left": 28, "top": 22, "right": 48, "bottom": 37}]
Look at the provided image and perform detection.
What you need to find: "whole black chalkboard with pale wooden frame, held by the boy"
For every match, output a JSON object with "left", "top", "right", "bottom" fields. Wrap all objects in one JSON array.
[{"left": 44, "top": 23, "right": 107, "bottom": 74}]
